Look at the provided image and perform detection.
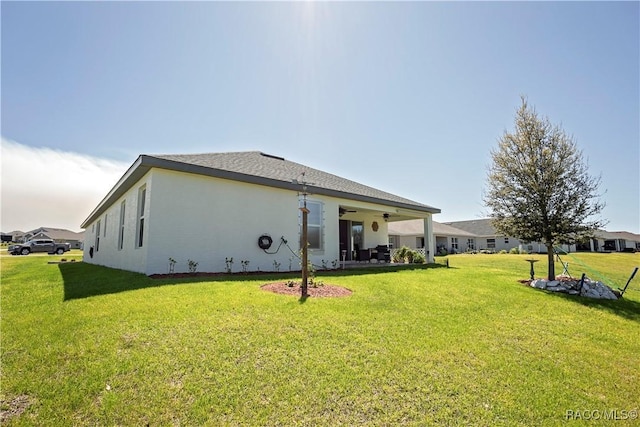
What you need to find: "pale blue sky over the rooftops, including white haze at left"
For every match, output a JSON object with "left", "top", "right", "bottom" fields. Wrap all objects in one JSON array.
[{"left": 0, "top": 1, "right": 640, "bottom": 233}]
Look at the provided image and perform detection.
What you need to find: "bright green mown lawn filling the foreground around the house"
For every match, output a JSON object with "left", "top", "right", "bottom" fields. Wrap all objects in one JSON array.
[{"left": 0, "top": 253, "right": 640, "bottom": 426}]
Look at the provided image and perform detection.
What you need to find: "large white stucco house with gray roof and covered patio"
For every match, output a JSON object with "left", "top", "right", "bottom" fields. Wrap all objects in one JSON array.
[{"left": 82, "top": 151, "right": 440, "bottom": 275}]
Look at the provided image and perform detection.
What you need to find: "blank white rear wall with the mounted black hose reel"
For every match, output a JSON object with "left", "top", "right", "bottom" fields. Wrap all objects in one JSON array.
[{"left": 146, "top": 169, "right": 310, "bottom": 274}]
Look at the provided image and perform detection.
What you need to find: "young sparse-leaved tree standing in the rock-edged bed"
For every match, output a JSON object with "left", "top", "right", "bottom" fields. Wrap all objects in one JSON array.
[{"left": 484, "top": 97, "right": 606, "bottom": 280}]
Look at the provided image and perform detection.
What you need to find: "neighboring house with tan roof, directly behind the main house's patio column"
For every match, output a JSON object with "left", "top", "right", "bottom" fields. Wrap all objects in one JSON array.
[{"left": 389, "top": 220, "right": 477, "bottom": 253}]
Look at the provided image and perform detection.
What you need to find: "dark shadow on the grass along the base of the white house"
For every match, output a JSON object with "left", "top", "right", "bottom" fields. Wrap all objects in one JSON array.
[{"left": 58, "top": 262, "right": 446, "bottom": 303}]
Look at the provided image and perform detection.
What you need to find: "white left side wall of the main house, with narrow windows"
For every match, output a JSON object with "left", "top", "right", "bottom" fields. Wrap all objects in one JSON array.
[{"left": 83, "top": 173, "right": 153, "bottom": 273}]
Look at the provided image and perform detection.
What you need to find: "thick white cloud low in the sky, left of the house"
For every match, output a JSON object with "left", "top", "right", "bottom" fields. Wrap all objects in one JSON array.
[{"left": 0, "top": 137, "right": 129, "bottom": 232}]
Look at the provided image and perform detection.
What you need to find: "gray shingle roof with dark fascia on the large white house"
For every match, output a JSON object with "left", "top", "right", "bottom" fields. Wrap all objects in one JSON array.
[{"left": 82, "top": 151, "right": 440, "bottom": 228}]
